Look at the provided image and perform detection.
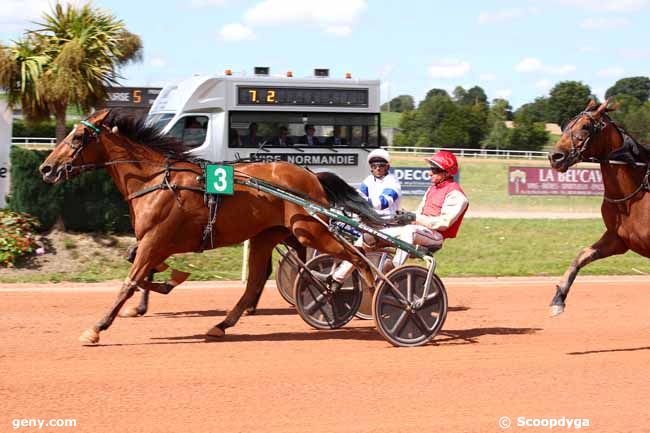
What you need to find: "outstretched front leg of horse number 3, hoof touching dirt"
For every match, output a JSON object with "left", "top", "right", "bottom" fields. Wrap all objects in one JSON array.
[{"left": 79, "top": 239, "right": 167, "bottom": 343}]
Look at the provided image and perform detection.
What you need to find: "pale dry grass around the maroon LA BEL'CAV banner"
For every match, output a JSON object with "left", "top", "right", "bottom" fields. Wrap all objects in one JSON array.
[{"left": 392, "top": 156, "right": 602, "bottom": 213}]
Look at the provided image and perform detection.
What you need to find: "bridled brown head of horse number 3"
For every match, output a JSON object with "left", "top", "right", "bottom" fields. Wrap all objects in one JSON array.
[{"left": 39, "top": 110, "right": 109, "bottom": 183}]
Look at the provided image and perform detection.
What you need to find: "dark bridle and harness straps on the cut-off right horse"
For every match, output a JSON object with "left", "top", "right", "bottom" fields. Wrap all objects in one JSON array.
[{"left": 564, "top": 111, "right": 650, "bottom": 204}]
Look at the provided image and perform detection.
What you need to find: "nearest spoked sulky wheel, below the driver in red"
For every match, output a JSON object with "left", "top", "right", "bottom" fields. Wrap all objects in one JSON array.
[{"left": 372, "top": 266, "right": 447, "bottom": 347}]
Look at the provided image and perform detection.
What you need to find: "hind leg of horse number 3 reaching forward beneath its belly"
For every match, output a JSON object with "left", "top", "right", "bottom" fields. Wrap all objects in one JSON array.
[{"left": 208, "top": 229, "right": 287, "bottom": 337}]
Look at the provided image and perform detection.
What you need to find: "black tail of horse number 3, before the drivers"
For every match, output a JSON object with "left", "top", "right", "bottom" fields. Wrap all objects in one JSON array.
[{"left": 316, "top": 171, "right": 386, "bottom": 224}]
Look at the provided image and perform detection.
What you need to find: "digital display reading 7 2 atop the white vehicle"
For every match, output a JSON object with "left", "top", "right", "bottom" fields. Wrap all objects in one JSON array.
[{"left": 237, "top": 86, "right": 368, "bottom": 107}]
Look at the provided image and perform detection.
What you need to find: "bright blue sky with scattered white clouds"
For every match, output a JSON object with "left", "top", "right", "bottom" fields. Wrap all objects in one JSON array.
[{"left": 0, "top": 0, "right": 650, "bottom": 107}]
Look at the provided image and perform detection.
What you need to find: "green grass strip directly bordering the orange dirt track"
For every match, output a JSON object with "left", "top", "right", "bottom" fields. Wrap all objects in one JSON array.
[{"left": 0, "top": 218, "right": 650, "bottom": 283}]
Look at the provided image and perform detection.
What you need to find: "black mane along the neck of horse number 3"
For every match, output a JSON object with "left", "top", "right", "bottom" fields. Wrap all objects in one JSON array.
[{"left": 103, "top": 110, "right": 189, "bottom": 160}]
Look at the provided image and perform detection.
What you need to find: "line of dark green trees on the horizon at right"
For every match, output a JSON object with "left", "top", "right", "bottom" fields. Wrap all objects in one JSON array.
[{"left": 382, "top": 77, "right": 650, "bottom": 150}]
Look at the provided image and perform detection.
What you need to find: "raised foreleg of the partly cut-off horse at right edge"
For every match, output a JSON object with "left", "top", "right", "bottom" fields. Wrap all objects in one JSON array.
[{"left": 551, "top": 231, "right": 628, "bottom": 316}]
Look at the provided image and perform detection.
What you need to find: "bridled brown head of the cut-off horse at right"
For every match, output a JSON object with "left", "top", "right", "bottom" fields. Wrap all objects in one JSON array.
[{"left": 548, "top": 99, "right": 615, "bottom": 172}]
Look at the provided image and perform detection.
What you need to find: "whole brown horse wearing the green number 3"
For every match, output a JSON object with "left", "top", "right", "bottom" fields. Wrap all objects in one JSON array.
[{"left": 40, "top": 110, "right": 376, "bottom": 343}]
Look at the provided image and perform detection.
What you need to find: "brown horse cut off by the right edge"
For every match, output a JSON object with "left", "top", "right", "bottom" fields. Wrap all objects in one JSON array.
[{"left": 548, "top": 100, "right": 650, "bottom": 316}]
